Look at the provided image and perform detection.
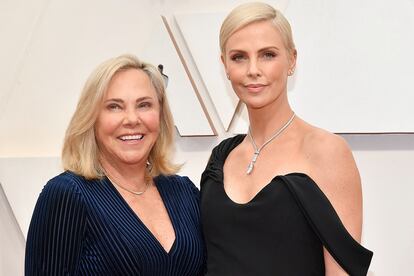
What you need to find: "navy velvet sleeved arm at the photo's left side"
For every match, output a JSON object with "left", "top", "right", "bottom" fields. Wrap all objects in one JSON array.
[{"left": 25, "top": 175, "right": 86, "bottom": 275}]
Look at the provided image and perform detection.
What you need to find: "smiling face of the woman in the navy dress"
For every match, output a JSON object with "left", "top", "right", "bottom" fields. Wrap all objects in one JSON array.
[{"left": 95, "top": 69, "right": 160, "bottom": 166}]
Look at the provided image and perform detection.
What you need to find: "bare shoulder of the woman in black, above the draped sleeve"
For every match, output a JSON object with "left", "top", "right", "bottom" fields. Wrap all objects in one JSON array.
[{"left": 303, "top": 119, "right": 362, "bottom": 240}]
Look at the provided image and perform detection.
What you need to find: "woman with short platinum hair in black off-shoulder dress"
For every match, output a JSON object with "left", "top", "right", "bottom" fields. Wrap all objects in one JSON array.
[{"left": 201, "top": 3, "right": 372, "bottom": 276}]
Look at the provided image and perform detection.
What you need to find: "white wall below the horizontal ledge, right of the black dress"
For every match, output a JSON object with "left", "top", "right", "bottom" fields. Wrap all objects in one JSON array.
[{"left": 345, "top": 135, "right": 414, "bottom": 276}]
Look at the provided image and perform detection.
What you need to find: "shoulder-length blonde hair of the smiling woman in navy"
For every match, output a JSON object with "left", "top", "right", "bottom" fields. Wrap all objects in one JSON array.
[{"left": 62, "top": 55, "right": 179, "bottom": 179}]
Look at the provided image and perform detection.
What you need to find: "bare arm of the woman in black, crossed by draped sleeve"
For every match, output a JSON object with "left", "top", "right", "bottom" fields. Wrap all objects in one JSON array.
[{"left": 311, "top": 134, "right": 362, "bottom": 276}]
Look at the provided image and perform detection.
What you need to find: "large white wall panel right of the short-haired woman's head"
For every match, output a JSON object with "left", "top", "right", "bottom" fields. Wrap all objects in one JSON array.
[{"left": 285, "top": 0, "right": 414, "bottom": 133}]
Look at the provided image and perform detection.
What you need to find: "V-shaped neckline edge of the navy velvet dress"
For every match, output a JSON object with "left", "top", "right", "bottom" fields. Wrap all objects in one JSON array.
[{"left": 105, "top": 177, "right": 178, "bottom": 256}]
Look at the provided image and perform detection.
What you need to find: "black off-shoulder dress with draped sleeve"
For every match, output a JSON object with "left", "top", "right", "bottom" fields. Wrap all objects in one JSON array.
[{"left": 201, "top": 135, "right": 373, "bottom": 276}]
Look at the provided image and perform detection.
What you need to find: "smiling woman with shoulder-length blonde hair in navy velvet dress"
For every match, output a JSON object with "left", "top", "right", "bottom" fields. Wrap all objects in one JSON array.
[{"left": 25, "top": 55, "right": 204, "bottom": 276}]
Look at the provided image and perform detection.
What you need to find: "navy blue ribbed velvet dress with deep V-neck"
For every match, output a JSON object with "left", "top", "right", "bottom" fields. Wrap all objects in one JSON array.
[{"left": 25, "top": 172, "right": 204, "bottom": 276}]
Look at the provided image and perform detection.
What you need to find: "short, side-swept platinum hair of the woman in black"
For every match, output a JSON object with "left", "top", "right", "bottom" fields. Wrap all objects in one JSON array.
[{"left": 219, "top": 2, "right": 296, "bottom": 54}]
